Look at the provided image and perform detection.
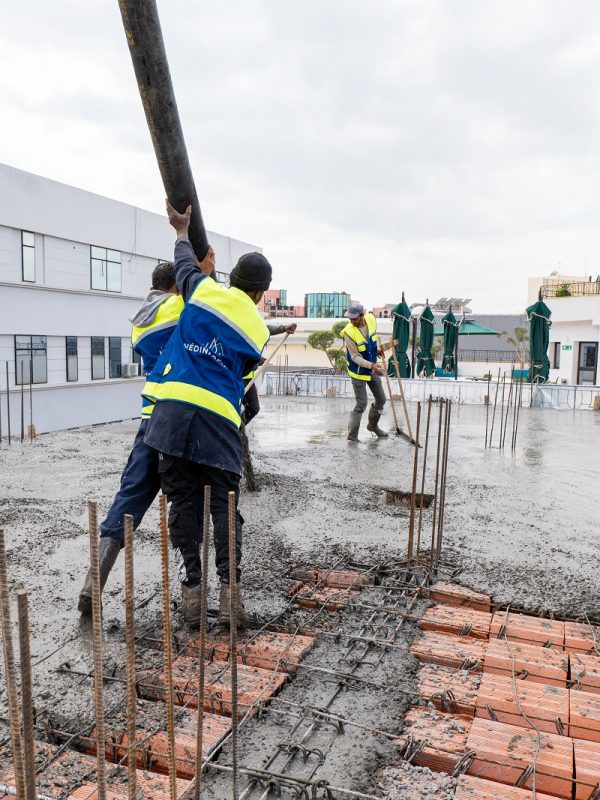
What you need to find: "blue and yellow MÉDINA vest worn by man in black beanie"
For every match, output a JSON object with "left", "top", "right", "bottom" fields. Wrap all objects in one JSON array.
[{"left": 142, "top": 278, "right": 269, "bottom": 427}]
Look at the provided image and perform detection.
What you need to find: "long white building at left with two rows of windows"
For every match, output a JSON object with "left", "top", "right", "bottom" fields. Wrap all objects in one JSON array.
[{"left": 0, "top": 164, "right": 259, "bottom": 436}]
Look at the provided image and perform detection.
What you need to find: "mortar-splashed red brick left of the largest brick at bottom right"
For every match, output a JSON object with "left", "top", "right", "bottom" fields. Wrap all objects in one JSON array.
[{"left": 397, "top": 707, "right": 471, "bottom": 773}]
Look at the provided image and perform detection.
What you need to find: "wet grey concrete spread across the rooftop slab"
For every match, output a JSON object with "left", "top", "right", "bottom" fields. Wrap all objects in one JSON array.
[{"left": 0, "top": 398, "right": 600, "bottom": 798}]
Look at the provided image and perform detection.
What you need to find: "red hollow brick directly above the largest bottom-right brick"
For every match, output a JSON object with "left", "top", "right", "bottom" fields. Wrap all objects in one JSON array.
[{"left": 476, "top": 672, "right": 569, "bottom": 736}]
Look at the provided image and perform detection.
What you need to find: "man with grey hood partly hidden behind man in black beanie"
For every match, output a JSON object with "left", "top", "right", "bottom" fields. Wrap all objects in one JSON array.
[{"left": 78, "top": 253, "right": 215, "bottom": 616}]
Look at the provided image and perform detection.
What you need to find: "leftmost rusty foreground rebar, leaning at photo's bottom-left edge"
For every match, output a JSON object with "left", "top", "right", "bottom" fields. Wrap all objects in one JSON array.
[{"left": 0, "top": 530, "right": 25, "bottom": 798}]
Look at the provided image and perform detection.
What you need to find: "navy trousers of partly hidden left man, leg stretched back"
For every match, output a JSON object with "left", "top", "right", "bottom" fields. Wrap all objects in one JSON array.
[{"left": 100, "top": 419, "right": 160, "bottom": 544}]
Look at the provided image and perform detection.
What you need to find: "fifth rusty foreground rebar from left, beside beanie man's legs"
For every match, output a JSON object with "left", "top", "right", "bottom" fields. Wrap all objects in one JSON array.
[{"left": 158, "top": 494, "right": 177, "bottom": 800}]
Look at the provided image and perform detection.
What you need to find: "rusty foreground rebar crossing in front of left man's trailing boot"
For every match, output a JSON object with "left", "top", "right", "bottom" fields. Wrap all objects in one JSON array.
[{"left": 88, "top": 500, "right": 106, "bottom": 800}]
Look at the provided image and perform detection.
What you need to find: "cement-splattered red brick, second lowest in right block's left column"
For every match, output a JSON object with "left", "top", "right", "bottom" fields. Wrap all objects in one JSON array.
[{"left": 417, "top": 664, "right": 481, "bottom": 717}]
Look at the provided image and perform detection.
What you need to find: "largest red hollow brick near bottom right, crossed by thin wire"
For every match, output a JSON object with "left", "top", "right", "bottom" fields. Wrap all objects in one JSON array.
[{"left": 467, "top": 719, "right": 573, "bottom": 800}]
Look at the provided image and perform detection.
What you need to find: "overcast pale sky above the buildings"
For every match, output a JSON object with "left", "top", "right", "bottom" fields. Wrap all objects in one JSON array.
[{"left": 0, "top": 0, "right": 600, "bottom": 312}]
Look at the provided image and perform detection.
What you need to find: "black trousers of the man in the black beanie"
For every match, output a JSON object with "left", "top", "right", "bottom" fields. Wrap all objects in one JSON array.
[{"left": 158, "top": 453, "right": 244, "bottom": 586}]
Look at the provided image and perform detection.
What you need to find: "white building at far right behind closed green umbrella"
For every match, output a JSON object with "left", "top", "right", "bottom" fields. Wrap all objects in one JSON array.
[{"left": 527, "top": 274, "right": 600, "bottom": 386}]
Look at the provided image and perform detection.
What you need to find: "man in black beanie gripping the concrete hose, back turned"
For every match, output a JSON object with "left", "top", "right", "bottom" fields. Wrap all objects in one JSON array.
[{"left": 142, "top": 201, "right": 272, "bottom": 628}]
